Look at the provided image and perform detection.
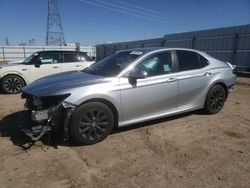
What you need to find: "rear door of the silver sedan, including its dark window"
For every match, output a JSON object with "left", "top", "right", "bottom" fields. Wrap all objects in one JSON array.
[{"left": 175, "top": 50, "right": 211, "bottom": 110}]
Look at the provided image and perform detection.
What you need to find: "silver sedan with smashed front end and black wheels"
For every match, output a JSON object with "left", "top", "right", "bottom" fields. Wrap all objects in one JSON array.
[{"left": 22, "top": 48, "right": 236, "bottom": 144}]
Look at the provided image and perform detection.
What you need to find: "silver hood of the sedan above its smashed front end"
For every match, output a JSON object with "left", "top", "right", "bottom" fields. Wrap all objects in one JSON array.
[{"left": 22, "top": 71, "right": 110, "bottom": 96}]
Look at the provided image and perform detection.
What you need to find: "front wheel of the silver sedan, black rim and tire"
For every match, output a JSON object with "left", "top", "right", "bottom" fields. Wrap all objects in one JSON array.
[{"left": 69, "top": 102, "right": 114, "bottom": 145}]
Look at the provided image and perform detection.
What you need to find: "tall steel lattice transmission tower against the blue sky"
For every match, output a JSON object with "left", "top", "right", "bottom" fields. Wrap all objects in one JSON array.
[{"left": 46, "top": 0, "right": 66, "bottom": 46}]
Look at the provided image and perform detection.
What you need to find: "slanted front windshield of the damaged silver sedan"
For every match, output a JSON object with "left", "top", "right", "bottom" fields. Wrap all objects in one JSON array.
[{"left": 83, "top": 51, "right": 143, "bottom": 77}]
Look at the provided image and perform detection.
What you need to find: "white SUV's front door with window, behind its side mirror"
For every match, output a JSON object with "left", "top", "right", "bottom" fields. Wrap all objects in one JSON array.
[{"left": 30, "top": 51, "right": 62, "bottom": 81}]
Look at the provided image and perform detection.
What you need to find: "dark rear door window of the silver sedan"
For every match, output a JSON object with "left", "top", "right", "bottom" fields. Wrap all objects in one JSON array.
[{"left": 176, "top": 50, "right": 200, "bottom": 71}]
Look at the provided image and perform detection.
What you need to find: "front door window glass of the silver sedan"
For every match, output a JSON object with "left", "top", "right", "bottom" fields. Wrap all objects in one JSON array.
[{"left": 136, "top": 51, "right": 172, "bottom": 77}]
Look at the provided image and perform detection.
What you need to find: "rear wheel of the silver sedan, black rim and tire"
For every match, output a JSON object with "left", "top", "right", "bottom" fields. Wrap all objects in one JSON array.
[{"left": 204, "top": 84, "right": 227, "bottom": 114}]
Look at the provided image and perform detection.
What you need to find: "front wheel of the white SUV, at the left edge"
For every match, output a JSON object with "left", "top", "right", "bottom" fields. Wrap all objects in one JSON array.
[{"left": 1, "top": 75, "right": 25, "bottom": 94}]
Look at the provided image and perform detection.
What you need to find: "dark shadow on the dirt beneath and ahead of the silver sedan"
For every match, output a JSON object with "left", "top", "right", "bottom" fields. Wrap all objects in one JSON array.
[{"left": 0, "top": 111, "right": 202, "bottom": 150}]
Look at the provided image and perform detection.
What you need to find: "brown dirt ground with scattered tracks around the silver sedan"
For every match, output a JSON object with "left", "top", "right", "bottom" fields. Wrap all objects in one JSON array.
[{"left": 0, "top": 78, "right": 250, "bottom": 188}]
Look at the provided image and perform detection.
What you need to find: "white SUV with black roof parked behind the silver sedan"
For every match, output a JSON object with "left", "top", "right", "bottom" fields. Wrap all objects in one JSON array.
[{"left": 0, "top": 51, "right": 94, "bottom": 93}]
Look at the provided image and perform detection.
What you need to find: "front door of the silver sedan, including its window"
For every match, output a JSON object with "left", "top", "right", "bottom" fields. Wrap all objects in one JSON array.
[{"left": 120, "top": 51, "right": 178, "bottom": 125}]
